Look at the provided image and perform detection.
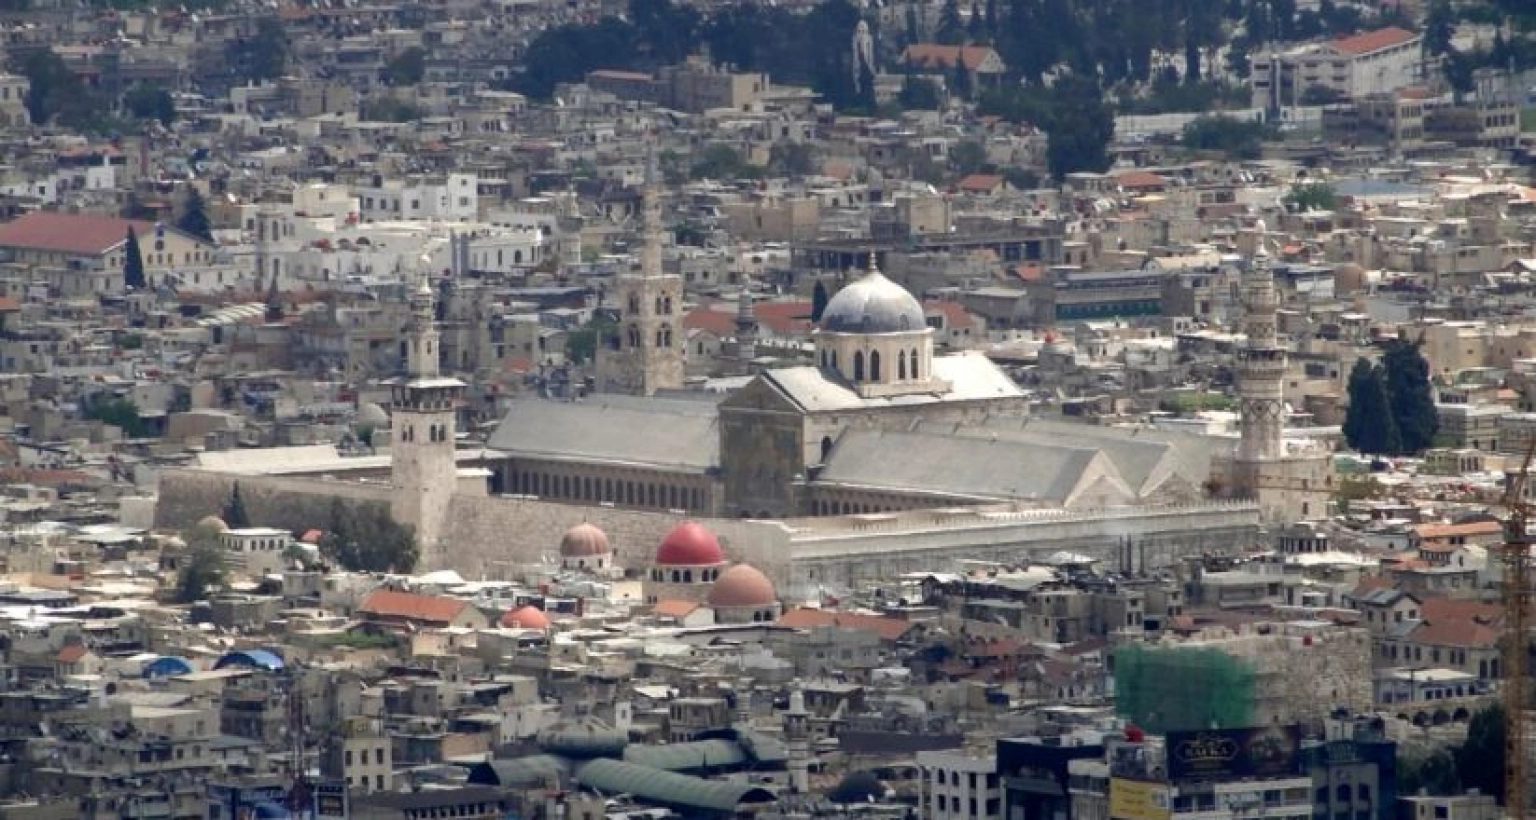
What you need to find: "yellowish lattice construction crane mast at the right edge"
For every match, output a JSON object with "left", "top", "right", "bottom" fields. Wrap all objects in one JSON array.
[{"left": 1501, "top": 441, "right": 1536, "bottom": 820}]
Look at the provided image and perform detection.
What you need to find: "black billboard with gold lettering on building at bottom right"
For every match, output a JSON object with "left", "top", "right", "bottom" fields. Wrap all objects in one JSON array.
[{"left": 1167, "top": 726, "right": 1301, "bottom": 783}]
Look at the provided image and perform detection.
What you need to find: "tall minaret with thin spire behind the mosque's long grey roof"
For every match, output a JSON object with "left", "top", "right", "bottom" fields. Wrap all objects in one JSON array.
[{"left": 598, "top": 149, "right": 687, "bottom": 396}]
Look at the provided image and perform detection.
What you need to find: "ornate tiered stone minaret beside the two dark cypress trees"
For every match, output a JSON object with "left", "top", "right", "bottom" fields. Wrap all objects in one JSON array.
[{"left": 1238, "top": 221, "right": 1286, "bottom": 462}]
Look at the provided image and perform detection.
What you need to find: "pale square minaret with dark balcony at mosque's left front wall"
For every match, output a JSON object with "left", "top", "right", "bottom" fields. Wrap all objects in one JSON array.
[{"left": 390, "top": 270, "right": 464, "bottom": 568}]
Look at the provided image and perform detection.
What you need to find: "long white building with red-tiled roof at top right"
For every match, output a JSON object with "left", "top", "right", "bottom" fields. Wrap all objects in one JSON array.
[{"left": 1250, "top": 28, "right": 1422, "bottom": 109}]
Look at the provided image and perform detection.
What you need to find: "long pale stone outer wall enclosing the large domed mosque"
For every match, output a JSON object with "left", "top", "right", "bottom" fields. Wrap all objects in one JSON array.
[{"left": 155, "top": 470, "right": 1260, "bottom": 596}]
